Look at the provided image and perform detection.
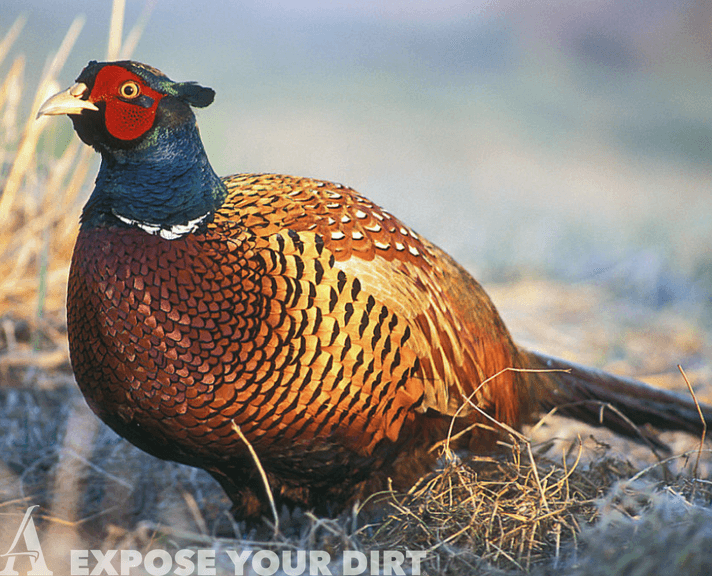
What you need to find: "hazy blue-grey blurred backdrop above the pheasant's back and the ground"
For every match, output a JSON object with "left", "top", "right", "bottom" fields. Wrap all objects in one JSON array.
[{"left": 0, "top": 0, "right": 712, "bottom": 323}]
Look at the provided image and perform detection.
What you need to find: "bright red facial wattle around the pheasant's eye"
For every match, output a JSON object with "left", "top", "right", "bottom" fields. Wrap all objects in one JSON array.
[{"left": 89, "top": 65, "right": 164, "bottom": 140}]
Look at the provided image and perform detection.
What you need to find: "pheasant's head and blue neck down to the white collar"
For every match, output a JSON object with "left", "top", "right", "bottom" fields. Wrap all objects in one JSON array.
[{"left": 38, "top": 61, "right": 226, "bottom": 239}]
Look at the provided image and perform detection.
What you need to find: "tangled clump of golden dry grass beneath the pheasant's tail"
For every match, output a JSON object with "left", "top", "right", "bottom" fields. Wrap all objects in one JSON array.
[{"left": 362, "top": 451, "right": 600, "bottom": 573}]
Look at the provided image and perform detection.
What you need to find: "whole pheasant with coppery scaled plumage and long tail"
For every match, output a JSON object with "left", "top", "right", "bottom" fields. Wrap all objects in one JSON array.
[{"left": 38, "top": 61, "right": 712, "bottom": 519}]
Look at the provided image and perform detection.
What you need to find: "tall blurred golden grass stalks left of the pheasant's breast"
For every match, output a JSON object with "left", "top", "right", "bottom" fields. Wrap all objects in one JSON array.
[{"left": 0, "top": 19, "right": 91, "bottom": 324}]
